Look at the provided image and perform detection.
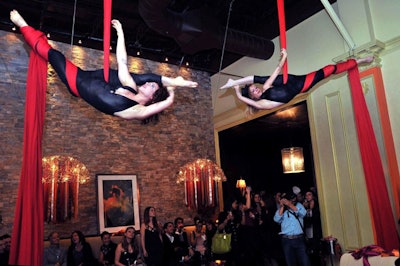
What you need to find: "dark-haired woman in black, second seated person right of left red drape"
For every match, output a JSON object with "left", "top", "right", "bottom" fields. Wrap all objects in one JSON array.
[{"left": 67, "top": 230, "right": 97, "bottom": 266}]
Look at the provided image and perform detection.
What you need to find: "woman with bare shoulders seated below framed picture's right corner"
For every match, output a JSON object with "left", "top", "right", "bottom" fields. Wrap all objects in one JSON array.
[{"left": 114, "top": 226, "right": 142, "bottom": 266}]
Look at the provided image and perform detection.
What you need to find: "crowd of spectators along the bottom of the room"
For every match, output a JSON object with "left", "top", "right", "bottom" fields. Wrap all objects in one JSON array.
[{"left": 0, "top": 186, "right": 318, "bottom": 266}]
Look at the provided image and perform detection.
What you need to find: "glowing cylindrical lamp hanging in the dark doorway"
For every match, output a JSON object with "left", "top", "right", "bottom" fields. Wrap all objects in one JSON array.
[{"left": 281, "top": 147, "right": 304, "bottom": 174}]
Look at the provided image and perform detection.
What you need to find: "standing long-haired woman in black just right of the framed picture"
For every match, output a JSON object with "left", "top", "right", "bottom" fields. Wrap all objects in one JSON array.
[{"left": 140, "top": 207, "right": 163, "bottom": 266}]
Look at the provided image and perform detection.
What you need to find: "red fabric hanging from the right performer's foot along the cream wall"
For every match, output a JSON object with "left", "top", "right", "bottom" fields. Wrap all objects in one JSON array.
[{"left": 348, "top": 67, "right": 399, "bottom": 250}]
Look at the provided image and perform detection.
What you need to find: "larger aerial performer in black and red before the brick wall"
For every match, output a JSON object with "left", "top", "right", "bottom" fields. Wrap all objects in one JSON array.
[{"left": 10, "top": 10, "right": 198, "bottom": 122}]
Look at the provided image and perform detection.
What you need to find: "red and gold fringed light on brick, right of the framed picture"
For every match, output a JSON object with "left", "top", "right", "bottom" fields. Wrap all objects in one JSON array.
[{"left": 176, "top": 159, "right": 226, "bottom": 211}]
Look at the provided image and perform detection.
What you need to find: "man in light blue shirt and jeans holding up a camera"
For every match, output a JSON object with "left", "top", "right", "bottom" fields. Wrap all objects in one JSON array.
[{"left": 274, "top": 193, "right": 310, "bottom": 266}]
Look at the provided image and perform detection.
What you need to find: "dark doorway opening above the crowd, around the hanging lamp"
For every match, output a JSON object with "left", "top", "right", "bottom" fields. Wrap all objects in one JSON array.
[{"left": 218, "top": 101, "right": 315, "bottom": 203}]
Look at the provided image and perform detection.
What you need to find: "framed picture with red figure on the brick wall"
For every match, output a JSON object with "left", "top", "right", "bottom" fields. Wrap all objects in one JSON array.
[{"left": 96, "top": 174, "right": 140, "bottom": 233}]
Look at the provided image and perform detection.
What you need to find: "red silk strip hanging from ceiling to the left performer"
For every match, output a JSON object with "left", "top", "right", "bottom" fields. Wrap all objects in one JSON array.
[{"left": 103, "top": 0, "right": 112, "bottom": 82}]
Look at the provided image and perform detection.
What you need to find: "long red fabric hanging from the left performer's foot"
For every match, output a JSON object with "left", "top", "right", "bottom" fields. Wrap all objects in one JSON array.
[{"left": 9, "top": 51, "right": 47, "bottom": 266}]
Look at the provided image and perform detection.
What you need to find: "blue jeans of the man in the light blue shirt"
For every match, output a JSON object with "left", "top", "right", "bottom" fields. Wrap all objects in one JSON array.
[{"left": 282, "top": 237, "right": 311, "bottom": 266}]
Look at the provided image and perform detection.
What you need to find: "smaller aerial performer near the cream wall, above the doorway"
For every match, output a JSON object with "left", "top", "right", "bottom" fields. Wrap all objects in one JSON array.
[{"left": 220, "top": 49, "right": 374, "bottom": 113}]
